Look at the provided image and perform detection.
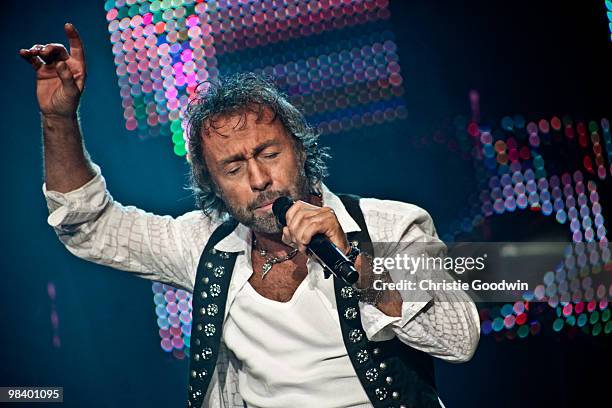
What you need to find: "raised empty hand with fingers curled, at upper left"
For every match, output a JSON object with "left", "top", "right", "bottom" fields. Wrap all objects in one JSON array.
[{"left": 19, "top": 23, "right": 86, "bottom": 117}]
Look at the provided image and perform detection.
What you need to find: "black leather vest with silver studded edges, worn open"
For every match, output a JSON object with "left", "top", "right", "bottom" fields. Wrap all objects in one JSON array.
[{"left": 187, "top": 195, "right": 440, "bottom": 408}]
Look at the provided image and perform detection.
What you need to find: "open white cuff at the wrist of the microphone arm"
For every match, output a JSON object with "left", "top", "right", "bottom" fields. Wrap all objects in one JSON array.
[{"left": 361, "top": 291, "right": 433, "bottom": 341}]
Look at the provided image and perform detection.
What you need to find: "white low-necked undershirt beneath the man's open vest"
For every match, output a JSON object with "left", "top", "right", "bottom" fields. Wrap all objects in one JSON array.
[{"left": 223, "top": 276, "right": 372, "bottom": 408}]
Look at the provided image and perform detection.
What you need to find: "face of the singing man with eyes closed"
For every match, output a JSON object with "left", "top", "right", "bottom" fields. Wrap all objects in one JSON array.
[{"left": 202, "top": 109, "right": 309, "bottom": 234}]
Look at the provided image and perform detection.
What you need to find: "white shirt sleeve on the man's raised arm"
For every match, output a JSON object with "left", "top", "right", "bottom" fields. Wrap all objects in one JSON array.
[{"left": 43, "top": 164, "right": 215, "bottom": 291}]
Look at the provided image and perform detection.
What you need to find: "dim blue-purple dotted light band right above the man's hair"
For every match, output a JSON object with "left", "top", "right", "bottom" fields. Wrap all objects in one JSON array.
[{"left": 218, "top": 22, "right": 406, "bottom": 133}]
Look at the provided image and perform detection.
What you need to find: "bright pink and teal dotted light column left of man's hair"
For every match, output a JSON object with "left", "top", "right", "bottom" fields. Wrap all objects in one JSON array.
[{"left": 104, "top": 0, "right": 218, "bottom": 155}]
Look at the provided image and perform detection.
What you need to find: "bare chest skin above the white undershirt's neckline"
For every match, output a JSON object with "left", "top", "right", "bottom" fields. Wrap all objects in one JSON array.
[{"left": 249, "top": 252, "right": 308, "bottom": 302}]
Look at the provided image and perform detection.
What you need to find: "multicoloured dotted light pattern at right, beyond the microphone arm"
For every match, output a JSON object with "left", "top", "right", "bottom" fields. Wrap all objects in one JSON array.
[{"left": 430, "top": 116, "right": 612, "bottom": 339}]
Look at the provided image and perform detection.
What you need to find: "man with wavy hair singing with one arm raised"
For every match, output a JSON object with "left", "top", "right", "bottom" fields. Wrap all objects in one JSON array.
[{"left": 20, "top": 24, "right": 479, "bottom": 408}]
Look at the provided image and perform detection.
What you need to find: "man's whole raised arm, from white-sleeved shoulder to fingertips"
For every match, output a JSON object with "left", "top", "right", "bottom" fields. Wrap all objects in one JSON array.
[{"left": 19, "top": 24, "right": 215, "bottom": 290}]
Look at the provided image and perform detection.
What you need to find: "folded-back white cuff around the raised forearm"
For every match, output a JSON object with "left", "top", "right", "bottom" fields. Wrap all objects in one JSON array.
[{"left": 42, "top": 163, "right": 110, "bottom": 227}]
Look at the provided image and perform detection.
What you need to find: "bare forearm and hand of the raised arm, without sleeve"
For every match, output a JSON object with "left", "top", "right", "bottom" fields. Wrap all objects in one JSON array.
[{"left": 19, "top": 23, "right": 95, "bottom": 193}]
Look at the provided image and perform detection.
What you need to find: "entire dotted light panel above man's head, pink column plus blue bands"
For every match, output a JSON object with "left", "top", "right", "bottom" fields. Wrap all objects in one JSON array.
[{"left": 105, "top": 0, "right": 406, "bottom": 160}]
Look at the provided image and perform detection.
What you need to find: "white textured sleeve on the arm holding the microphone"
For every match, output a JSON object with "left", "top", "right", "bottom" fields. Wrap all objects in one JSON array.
[{"left": 360, "top": 199, "right": 480, "bottom": 362}]
